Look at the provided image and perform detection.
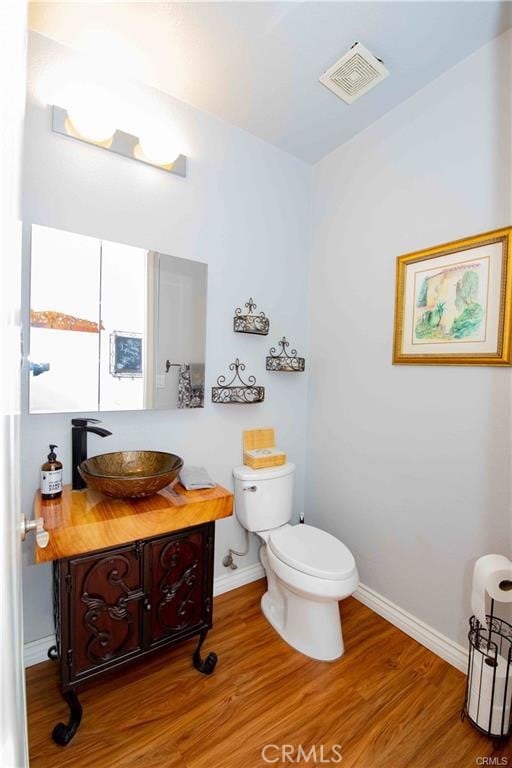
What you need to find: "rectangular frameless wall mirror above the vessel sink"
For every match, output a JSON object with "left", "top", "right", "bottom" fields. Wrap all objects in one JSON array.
[{"left": 29, "top": 225, "right": 208, "bottom": 413}]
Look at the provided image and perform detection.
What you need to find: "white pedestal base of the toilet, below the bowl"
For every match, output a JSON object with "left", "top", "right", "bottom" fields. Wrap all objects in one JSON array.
[{"left": 261, "top": 574, "right": 345, "bottom": 661}]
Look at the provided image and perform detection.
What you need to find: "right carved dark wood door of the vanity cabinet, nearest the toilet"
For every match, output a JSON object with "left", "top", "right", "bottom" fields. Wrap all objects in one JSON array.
[{"left": 146, "top": 525, "right": 213, "bottom": 645}]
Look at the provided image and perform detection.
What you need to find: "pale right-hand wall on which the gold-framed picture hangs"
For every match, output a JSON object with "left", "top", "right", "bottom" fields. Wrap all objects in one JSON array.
[{"left": 306, "top": 28, "right": 512, "bottom": 645}]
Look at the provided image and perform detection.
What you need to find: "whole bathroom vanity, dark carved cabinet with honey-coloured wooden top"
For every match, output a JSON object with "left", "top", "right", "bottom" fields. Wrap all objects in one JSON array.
[{"left": 35, "top": 484, "right": 233, "bottom": 745}]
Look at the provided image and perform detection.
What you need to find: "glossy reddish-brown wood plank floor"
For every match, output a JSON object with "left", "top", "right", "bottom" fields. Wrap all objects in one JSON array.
[{"left": 27, "top": 581, "right": 512, "bottom": 768}]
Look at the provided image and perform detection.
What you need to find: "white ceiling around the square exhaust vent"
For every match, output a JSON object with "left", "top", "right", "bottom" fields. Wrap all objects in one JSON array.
[{"left": 30, "top": 1, "right": 512, "bottom": 163}]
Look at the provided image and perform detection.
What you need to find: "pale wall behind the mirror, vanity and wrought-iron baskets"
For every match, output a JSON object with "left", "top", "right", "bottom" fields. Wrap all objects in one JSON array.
[{"left": 22, "top": 34, "right": 311, "bottom": 641}]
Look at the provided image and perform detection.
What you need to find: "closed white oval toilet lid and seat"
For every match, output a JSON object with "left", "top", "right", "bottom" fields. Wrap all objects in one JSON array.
[{"left": 268, "top": 524, "right": 356, "bottom": 580}]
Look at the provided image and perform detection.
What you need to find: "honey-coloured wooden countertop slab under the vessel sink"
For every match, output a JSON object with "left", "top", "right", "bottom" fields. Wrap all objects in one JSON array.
[{"left": 34, "top": 483, "right": 233, "bottom": 563}]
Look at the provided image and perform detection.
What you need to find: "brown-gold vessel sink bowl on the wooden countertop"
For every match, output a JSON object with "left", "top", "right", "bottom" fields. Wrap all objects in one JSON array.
[{"left": 78, "top": 451, "right": 183, "bottom": 499}]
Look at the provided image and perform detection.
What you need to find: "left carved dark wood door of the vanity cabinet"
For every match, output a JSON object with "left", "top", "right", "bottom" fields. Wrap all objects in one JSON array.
[{"left": 66, "top": 543, "right": 144, "bottom": 679}]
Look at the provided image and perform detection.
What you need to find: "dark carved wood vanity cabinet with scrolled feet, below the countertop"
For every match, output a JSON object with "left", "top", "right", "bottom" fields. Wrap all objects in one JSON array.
[{"left": 50, "top": 522, "right": 217, "bottom": 744}]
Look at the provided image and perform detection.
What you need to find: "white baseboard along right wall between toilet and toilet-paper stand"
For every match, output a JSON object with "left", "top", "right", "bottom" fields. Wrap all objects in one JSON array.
[{"left": 353, "top": 584, "right": 468, "bottom": 673}]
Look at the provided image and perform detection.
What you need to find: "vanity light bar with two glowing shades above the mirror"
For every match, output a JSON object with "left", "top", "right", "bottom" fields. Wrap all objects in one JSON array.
[{"left": 52, "top": 105, "right": 187, "bottom": 177}]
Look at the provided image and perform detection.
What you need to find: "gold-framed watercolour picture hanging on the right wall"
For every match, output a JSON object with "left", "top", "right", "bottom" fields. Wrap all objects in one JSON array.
[{"left": 393, "top": 227, "right": 512, "bottom": 365}]
